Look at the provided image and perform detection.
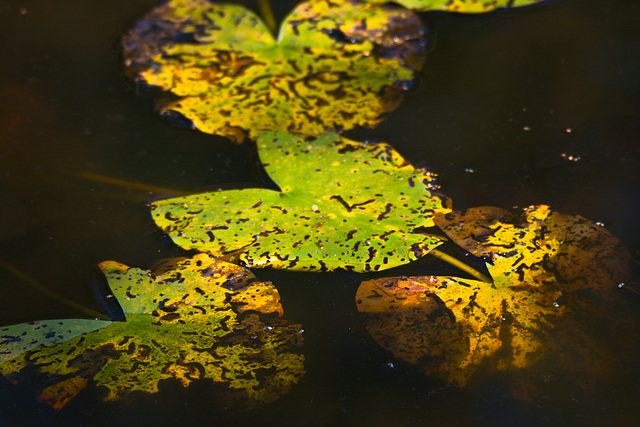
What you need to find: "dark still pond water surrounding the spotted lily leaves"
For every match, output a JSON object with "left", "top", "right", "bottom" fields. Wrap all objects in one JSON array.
[{"left": 0, "top": 0, "right": 640, "bottom": 426}]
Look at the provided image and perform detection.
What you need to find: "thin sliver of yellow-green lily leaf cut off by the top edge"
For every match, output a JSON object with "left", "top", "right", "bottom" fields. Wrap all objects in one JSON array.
[{"left": 365, "top": 0, "right": 548, "bottom": 13}]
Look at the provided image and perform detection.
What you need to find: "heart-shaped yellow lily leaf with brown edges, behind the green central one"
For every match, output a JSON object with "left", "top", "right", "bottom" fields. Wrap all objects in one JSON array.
[{"left": 122, "top": 0, "right": 425, "bottom": 142}]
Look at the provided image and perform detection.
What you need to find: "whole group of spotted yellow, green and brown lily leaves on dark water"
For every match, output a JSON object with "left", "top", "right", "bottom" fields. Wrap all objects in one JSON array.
[{"left": 0, "top": 0, "right": 629, "bottom": 409}]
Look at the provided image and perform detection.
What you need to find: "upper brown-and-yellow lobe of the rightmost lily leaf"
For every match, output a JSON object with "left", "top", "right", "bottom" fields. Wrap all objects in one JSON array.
[{"left": 434, "top": 205, "right": 629, "bottom": 298}]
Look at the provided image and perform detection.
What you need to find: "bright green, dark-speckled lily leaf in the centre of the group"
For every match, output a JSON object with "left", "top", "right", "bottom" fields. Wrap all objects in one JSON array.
[{"left": 151, "top": 133, "right": 450, "bottom": 271}]
